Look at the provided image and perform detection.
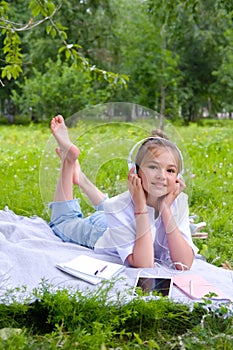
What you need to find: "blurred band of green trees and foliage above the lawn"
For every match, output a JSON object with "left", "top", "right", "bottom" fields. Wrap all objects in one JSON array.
[{"left": 0, "top": 0, "right": 233, "bottom": 123}]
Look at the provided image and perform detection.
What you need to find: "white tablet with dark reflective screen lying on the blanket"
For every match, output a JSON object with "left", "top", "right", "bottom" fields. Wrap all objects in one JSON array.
[{"left": 134, "top": 274, "right": 173, "bottom": 298}]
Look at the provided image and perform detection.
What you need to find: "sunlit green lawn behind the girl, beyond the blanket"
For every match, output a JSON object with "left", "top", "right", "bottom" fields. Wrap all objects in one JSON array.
[{"left": 0, "top": 121, "right": 233, "bottom": 265}]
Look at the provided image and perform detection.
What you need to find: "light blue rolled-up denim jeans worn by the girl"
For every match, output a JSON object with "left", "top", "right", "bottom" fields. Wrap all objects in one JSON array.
[{"left": 49, "top": 199, "right": 107, "bottom": 249}]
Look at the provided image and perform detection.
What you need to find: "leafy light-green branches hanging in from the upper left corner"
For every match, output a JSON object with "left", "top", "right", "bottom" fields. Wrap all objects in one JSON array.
[{"left": 0, "top": 0, "right": 128, "bottom": 119}]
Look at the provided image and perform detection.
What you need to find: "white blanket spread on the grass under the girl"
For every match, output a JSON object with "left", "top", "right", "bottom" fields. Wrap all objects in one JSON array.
[{"left": 0, "top": 208, "right": 233, "bottom": 301}]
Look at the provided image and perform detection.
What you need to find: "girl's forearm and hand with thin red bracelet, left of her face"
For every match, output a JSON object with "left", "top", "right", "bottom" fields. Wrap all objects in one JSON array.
[{"left": 127, "top": 169, "right": 154, "bottom": 267}]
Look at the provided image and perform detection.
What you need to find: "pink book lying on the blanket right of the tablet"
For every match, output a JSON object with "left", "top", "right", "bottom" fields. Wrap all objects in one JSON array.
[{"left": 173, "top": 274, "right": 231, "bottom": 301}]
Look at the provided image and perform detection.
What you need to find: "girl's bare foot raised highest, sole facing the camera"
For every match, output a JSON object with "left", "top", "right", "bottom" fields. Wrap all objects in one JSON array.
[{"left": 50, "top": 115, "right": 80, "bottom": 161}]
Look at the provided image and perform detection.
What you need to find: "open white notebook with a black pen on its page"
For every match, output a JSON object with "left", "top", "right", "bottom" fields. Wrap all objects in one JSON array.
[{"left": 56, "top": 255, "right": 125, "bottom": 284}]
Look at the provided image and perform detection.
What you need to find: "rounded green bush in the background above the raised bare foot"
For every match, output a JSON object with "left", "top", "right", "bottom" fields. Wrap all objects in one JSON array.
[{"left": 12, "top": 58, "right": 121, "bottom": 122}]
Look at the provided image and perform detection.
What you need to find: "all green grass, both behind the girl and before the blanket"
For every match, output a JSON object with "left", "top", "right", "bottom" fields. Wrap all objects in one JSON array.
[{"left": 0, "top": 117, "right": 233, "bottom": 350}]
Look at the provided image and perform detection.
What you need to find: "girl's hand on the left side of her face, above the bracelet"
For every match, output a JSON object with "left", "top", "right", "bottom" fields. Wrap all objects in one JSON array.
[{"left": 128, "top": 166, "right": 146, "bottom": 211}]
